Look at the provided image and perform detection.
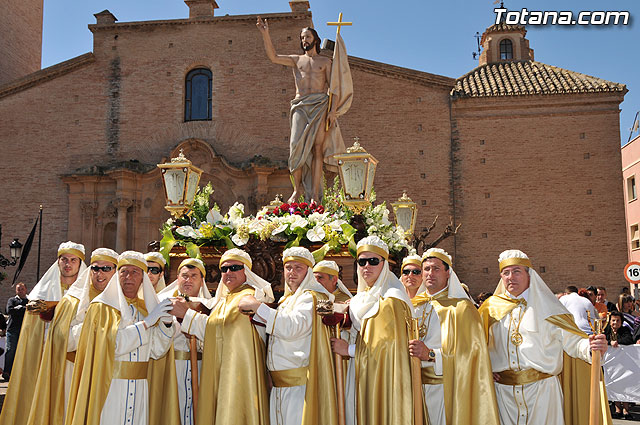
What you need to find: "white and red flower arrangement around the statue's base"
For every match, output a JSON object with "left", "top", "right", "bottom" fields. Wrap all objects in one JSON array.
[{"left": 160, "top": 177, "right": 412, "bottom": 259}]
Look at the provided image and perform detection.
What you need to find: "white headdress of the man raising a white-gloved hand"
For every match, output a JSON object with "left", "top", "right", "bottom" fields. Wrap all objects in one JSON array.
[{"left": 91, "top": 251, "right": 158, "bottom": 328}]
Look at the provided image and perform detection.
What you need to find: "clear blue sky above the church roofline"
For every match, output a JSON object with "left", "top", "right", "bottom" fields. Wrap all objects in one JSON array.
[{"left": 42, "top": 0, "right": 640, "bottom": 144}]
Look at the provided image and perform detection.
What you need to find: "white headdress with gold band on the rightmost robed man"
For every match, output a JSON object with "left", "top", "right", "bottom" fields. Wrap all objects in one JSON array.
[{"left": 494, "top": 249, "right": 569, "bottom": 332}]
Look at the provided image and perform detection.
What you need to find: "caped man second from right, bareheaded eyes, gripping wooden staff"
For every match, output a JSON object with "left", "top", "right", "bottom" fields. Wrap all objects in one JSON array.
[{"left": 402, "top": 248, "right": 499, "bottom": 425}]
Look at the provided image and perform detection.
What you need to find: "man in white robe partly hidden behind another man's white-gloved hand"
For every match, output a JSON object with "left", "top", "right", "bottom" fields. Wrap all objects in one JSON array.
[{"left": 158, "top": 258, "right": 211, "bottom": 425}]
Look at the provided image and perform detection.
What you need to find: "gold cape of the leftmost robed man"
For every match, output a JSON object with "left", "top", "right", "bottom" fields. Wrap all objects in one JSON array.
[{"left": 0, "top": 311, "right": 45, "bottom": 425}]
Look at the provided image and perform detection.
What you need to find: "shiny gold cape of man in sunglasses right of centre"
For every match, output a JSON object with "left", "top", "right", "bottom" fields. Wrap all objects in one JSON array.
[{"left": 354, "top": 297, "right": 418, "bottom": 425}]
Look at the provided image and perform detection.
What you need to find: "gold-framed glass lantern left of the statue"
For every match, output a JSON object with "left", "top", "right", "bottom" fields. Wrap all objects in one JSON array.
[{"left": 158, "top": 149, "right": 202, "bottom": 218}]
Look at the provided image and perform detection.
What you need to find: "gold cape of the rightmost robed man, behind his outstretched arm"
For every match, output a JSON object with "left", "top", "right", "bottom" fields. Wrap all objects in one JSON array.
[{"left": 478, "top": 295, "right": 612, "bottom": 425}]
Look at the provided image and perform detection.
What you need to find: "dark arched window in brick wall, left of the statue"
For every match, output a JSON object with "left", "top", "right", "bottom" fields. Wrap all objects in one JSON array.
[{"left": 184, "top": 68, "right": 213, "bottom": 121}]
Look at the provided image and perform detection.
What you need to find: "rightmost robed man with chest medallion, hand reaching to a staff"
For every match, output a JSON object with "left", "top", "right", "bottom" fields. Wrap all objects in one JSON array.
[{"left": 479, "top": 250, "right": 607, "bottom": 425}]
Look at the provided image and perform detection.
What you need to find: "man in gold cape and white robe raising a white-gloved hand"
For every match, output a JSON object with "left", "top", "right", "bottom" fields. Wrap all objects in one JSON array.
[{"left": 65, "top": 251, "right": 177, "bottom": 425}]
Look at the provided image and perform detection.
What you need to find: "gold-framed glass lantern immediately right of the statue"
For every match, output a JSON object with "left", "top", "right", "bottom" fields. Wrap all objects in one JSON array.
[{"left": 333, "top": 137, "right": 378, "bottom": 214}]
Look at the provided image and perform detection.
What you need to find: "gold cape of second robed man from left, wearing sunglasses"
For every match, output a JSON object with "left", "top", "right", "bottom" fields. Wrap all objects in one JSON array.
[{"left": 27, "top": 295, "right": 80, "bottom": 425}]
